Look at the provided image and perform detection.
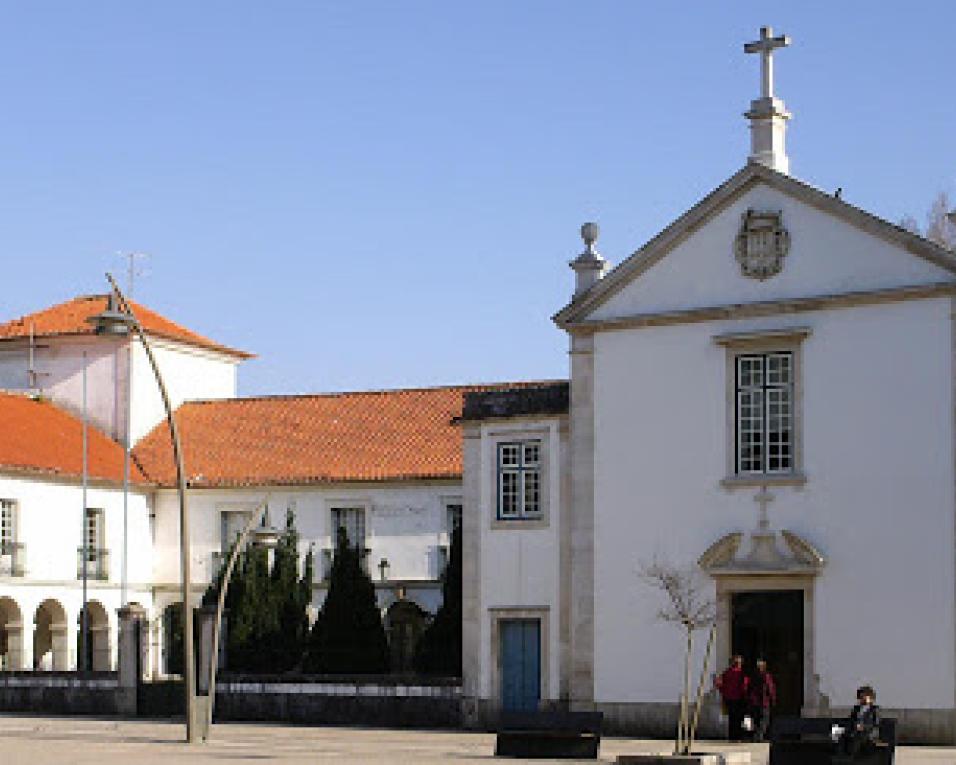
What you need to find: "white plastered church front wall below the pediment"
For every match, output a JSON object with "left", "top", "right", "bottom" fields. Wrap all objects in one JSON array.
[{"left": 594, "top": 298, "right": 956, "bottom": 708}]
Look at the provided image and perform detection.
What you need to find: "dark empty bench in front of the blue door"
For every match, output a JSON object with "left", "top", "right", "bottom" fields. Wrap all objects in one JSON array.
[{"left": 495, "top": 711, "right": 604, "bottom": 760}]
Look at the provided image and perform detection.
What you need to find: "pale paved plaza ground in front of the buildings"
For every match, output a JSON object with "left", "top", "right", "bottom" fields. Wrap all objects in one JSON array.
[{"left": 0, "top": 716, "right": 956, "bottom": 765}]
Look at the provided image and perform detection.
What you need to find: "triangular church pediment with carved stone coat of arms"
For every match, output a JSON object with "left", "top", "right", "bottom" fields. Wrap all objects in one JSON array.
[{"left": 554, "top": 163, "right": 956, "bottom": 329}]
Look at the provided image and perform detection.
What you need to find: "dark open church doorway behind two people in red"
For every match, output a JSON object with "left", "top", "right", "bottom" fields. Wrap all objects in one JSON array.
[{"left": 731, "top": 590, "right": 804, "bottom": 715}]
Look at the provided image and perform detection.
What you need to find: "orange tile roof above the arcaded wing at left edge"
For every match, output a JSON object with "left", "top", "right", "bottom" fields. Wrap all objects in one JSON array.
[{"left": 0, "top": 392, "right": 146, "bottom": 483}]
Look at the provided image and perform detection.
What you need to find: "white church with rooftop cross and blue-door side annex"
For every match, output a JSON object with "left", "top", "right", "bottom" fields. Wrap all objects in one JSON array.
[{"left": 463, "top": 30, "right": 956, "bottom": 741}]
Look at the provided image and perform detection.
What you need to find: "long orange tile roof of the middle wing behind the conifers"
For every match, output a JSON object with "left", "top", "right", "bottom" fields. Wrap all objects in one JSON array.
[{"left": 133, "top": 383, "right": 560, "bottom": 487}]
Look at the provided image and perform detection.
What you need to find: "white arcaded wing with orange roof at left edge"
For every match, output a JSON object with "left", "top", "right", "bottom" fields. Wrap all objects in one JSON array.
[{"left": 0, "top": 392, "right": 153, "bottom": 670}]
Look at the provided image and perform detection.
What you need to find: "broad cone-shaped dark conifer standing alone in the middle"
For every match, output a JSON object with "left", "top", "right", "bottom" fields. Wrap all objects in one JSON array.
[{"left": 305, "top": 528, "right": 388, "bottom": 674}]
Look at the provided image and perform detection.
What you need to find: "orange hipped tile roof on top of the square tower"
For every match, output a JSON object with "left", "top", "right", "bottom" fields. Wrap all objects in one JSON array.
[{"left": 0, "top": 295, "right": 252, "bottom": 359}]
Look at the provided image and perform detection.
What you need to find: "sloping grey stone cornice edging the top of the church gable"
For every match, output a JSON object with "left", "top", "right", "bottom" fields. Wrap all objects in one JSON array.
[{"left": 553, "top": 162, "right": 956, "bottom": 328}]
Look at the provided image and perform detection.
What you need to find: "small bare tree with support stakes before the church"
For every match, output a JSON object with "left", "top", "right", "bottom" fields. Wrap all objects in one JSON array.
[{"left": 638, "top": 561, "right": 717, "bottom": 754}]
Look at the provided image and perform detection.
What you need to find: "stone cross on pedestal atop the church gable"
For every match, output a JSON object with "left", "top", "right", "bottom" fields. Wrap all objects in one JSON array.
[{"left": 744, "top": 27, "right": 791, "bottom": 173}]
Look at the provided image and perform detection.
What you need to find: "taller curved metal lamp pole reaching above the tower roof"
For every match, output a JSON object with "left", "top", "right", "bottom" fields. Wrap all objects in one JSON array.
[{"left": 106, "top": 274, "right": 202, "bottom": 744}]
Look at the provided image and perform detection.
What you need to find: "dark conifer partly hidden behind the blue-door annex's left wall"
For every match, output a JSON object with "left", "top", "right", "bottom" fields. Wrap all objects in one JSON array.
[{"left": 414, "top": 524, "right": 461, "bottom": 677}]
